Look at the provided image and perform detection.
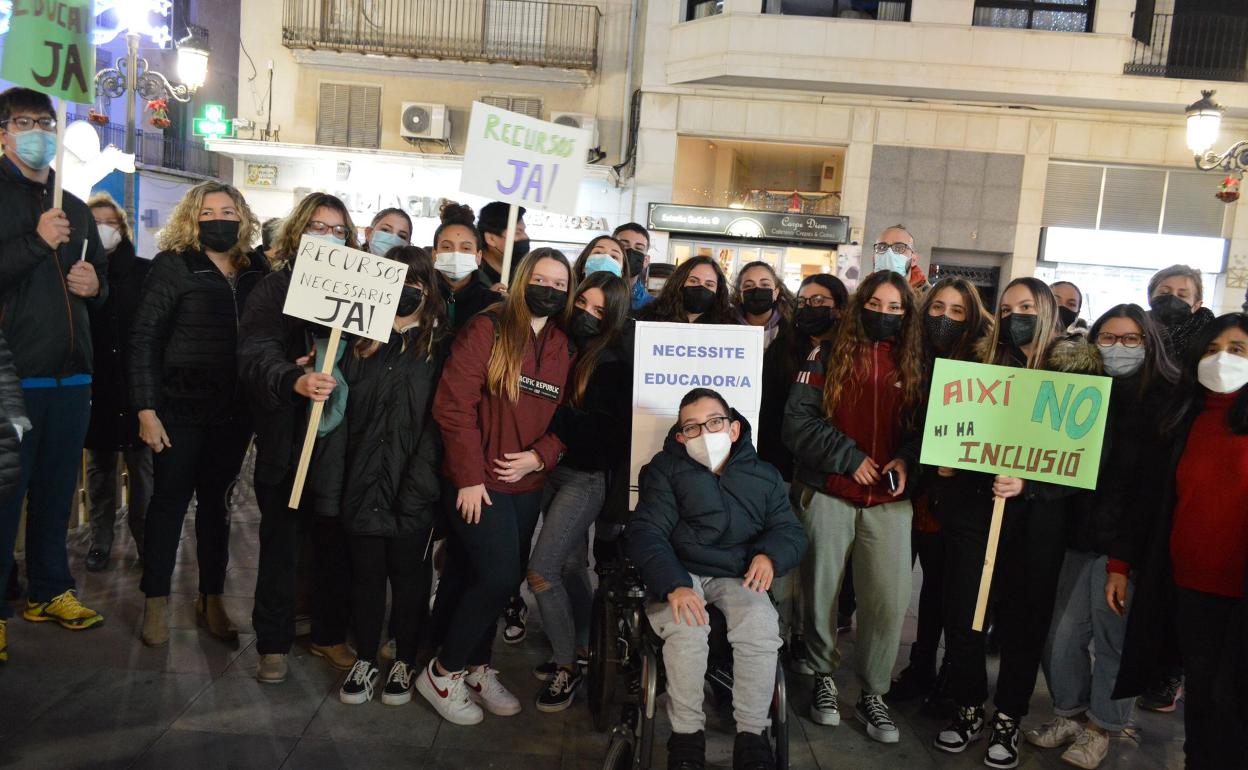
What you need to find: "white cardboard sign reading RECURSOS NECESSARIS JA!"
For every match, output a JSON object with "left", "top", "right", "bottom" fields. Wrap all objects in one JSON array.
[{"left": 282, "top": 235, "right": 407, "bottom": 342}]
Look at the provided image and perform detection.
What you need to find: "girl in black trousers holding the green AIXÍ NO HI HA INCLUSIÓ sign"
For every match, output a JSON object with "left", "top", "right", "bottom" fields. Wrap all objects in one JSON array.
[{"left": 931, "top": 278, "right": 1101, "bottom": 768}]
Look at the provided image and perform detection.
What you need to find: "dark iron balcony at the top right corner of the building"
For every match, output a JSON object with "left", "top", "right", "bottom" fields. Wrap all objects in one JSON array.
[{"left": 1122, "top": 14, "right": 1248, "bottom": 82}]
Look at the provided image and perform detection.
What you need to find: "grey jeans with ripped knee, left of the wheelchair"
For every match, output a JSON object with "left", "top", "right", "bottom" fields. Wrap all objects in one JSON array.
[{"left": 528, "top": 465, "right": 607, "bottom": 665}]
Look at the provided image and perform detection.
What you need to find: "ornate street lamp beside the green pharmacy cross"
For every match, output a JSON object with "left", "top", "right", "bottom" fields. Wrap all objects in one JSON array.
[{"left": 95, "top": 22, "right": 208, "bottom": 221}]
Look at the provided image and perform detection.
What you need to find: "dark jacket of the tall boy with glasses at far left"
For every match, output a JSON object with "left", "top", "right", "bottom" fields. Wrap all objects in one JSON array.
[{"left": 0, "top": 160, "right": 109, "bottom": 379}]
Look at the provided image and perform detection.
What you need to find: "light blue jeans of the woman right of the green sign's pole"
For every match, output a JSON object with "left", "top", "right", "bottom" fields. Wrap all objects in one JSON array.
[{"left": 1043, "top": 550, "right": 1136, "bottom": 733}]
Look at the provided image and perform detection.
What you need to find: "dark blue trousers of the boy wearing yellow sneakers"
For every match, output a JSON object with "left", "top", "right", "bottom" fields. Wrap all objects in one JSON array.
[{"left": 0, "top": 384, "right": 91, "bottom": 611}]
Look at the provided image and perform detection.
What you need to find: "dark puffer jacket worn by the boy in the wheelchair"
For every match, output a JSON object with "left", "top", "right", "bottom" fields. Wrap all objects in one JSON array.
[{"left": 625, "top": 411, "right": 806, "bottom": 599}]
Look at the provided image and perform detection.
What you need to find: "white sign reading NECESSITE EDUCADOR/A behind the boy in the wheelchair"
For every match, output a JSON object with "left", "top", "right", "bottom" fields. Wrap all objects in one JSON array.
[{"left": 629, "top": 321, "right": 765, "bottom": 508}]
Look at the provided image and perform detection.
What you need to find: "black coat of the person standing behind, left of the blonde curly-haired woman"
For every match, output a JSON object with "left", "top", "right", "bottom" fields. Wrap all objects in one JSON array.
[{"left": 84, "top": 240, "right": 151, "bottom": 452}]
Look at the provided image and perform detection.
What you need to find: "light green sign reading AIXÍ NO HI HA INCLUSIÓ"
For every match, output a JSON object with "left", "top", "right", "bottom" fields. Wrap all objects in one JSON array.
[{"left": 921, "top": 358, "right": 1111, "bottom": 489}]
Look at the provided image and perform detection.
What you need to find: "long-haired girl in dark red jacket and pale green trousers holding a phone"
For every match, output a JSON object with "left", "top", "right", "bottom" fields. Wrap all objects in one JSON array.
[{"left": 782, "top": 271, "right": 924, "bottom": 743}]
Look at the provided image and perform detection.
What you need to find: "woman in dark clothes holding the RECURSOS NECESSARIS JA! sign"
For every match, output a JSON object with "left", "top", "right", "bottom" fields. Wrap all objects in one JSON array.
[{"left": 238, "top": 192, "right": 356, "bottom": 684}]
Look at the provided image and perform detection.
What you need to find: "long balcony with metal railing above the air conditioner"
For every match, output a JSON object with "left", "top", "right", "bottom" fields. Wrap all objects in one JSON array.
[{"left": 282, "top": 0, "right": 602, "bottom": 70}]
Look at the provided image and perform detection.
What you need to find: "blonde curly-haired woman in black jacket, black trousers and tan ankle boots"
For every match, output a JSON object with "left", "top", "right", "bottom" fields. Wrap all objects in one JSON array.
[{"left": 130, "top": 182, "right": 268, "bottom": 646}]
